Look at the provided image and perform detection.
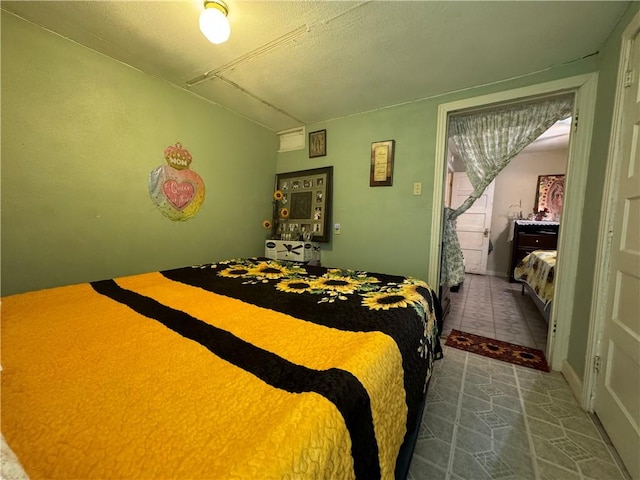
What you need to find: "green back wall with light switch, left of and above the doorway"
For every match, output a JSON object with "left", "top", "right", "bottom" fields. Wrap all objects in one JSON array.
[{"left": 277, "top": 57, "right": 597, "bottom": 279}]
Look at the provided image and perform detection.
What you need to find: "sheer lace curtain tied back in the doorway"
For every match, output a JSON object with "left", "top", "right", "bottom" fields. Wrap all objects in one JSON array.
[{"left": 440, "top": 94, "right": 573, "bottom": 286}]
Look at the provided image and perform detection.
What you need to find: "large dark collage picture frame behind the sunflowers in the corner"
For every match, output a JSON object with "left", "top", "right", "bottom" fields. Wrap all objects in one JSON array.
[{"left": 273, "top": 167, "right": 333, "bottom": 242}]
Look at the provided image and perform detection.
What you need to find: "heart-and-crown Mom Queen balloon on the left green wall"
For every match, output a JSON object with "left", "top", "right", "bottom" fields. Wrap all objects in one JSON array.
[{"left": 149, "top": 142, "right": 204, "bottom": 221}]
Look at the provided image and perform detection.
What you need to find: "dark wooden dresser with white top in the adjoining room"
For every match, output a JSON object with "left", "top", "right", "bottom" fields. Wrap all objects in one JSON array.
[{"left": 507, "top": 220, "right": 560, "bottom": 282}]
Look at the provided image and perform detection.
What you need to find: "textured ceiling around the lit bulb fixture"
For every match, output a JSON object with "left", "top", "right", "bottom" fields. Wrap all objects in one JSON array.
[{"left": 1, "top": 0, "right": 629, "bottom": 131}]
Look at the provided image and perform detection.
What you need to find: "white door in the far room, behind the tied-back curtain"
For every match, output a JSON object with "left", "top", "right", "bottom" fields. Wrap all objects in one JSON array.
[{"left": 451, "top": 172, "right": 494, "bottom": 275}]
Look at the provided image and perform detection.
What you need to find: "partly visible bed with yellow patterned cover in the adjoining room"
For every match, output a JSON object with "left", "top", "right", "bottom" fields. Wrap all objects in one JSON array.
[{"left": 513, "top": 250, "right": 558, "bottom": 323}]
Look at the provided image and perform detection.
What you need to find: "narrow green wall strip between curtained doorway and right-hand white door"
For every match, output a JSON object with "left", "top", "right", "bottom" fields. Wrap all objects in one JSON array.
[{"left": 567, "top": 2, "right": 640, "bottom": 378}]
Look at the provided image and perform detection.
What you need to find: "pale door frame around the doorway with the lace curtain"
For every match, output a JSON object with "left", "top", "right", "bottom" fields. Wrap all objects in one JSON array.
[{"left": 428, "top": 72, "right": 598, "bottom": 376}]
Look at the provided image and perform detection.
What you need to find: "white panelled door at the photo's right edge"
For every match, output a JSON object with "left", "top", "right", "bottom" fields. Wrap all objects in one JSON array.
[{"left": 594, "top": 21, "right": 640, "bottom": 478}]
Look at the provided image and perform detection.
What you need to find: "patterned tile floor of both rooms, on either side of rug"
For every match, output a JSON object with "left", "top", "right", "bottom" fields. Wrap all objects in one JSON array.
[{"left": 409, "top": 275, "right": 630, "bottom": 480}]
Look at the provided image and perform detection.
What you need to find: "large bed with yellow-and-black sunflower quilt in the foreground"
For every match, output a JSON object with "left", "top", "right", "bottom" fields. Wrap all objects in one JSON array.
[{"left": 1, "top": 258, "right": 442, "bottom": 479}]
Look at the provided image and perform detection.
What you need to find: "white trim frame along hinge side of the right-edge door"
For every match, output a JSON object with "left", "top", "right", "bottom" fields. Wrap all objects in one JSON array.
[{"left": 581, "top": 12, "right": 640, "bottom": 412}]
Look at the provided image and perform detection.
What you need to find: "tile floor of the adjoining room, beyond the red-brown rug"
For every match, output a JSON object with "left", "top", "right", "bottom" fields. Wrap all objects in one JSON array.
[{"left": 443, "top": 274, "right": 548, "bottom": 351}]
